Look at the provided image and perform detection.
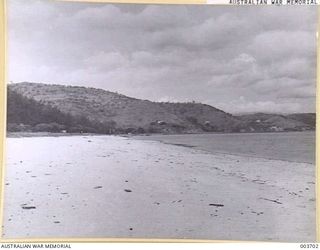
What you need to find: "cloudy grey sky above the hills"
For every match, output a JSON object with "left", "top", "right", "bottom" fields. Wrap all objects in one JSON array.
[{"left": 7, "top": 0, "right": 317, "bottom": 114}]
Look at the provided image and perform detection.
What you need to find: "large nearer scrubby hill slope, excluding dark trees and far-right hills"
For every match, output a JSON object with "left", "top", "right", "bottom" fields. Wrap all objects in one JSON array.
[{"left": 10, "top": 83, "right": 242, "bottom": 131}]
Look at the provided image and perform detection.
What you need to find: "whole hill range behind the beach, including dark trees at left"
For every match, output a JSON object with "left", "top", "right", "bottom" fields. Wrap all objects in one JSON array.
[{"left": 8, "top": 82, "right": 314, "bottom": 133}]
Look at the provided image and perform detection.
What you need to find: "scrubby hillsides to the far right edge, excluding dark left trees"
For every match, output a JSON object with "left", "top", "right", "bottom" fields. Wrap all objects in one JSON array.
[{"left": 9, "top": 83, "right": 315, "bottom": 132}]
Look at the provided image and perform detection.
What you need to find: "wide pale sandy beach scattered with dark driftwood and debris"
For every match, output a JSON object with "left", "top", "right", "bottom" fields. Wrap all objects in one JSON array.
[{"left": 3, "top": 136, "right": 316, "bottom": 242}]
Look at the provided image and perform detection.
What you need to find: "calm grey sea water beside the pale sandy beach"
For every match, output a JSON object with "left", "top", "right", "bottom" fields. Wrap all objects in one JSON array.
[{"left": 134, "top": 131, "right": 315, "bottom": 164}]
